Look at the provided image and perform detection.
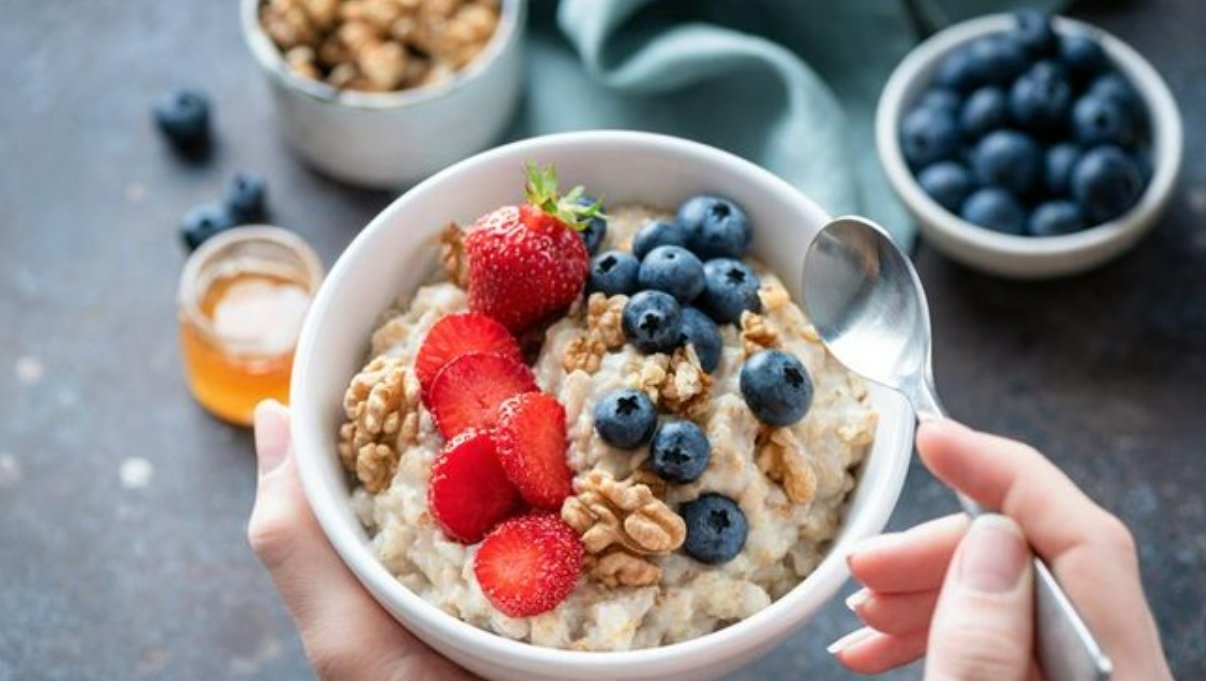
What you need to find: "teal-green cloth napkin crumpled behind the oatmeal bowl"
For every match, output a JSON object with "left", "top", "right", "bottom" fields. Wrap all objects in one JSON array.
[{"left": 511, "top": 0, "right": 1062, "bottom": 247}]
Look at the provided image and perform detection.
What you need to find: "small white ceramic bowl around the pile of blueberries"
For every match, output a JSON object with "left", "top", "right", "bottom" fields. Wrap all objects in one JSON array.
[{"left": 876, "top": 14, "right": 1183, "bottom": 278}]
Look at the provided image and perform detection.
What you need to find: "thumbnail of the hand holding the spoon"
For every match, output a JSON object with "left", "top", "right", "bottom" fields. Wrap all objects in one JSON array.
[{"left": 959, "top": 513, "right": 1030, "bottom": 593}]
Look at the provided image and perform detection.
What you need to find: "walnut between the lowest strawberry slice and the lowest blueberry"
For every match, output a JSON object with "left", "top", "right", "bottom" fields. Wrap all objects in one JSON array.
[{"left": 561, "top": 470, "right": 686, "bottom": 586}]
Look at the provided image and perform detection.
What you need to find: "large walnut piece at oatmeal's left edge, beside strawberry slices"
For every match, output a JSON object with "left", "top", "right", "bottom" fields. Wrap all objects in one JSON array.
[{"left": 339, "top": 357, "right": 418, "bottom": 494}]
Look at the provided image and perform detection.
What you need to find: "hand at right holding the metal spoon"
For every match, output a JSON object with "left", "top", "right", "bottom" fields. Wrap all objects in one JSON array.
[{"left": 830, "top": 421, "right": 1172, "bottom": 681}]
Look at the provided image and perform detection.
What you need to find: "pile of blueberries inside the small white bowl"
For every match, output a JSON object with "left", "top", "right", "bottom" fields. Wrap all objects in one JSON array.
[{"left": 900, "top": 11, "right": 1149, "bottom": 236}]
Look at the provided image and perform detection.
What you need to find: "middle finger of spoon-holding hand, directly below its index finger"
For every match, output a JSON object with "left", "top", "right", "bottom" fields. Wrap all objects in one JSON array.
[{"left": 847, "top": 513, "right": 971, "bottom": 593}]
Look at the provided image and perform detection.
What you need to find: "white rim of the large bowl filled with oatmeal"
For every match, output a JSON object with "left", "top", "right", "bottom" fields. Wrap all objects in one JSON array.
[{"left": 291, "top": 130, "right": 915, "bottom": 674}]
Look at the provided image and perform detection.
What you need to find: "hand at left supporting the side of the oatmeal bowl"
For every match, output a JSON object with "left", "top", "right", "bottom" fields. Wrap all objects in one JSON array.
[{"left": 247, "top": 400, "right": 475, "bottom": 681}]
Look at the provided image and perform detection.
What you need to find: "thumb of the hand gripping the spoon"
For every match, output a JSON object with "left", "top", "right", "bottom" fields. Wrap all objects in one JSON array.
[{"left": 925, "top": 513, "right": 1034, "bottom": 681}]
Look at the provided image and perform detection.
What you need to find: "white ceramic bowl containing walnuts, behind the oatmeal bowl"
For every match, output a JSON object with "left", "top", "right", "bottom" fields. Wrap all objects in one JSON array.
[{"left": 240, "top": 0, "right": 527, "bottom": 188}]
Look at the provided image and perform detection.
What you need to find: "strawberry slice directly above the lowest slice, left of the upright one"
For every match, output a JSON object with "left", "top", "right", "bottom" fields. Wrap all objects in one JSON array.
[{"left": 427, "top": 430, "right": 521, "bottom": 544}]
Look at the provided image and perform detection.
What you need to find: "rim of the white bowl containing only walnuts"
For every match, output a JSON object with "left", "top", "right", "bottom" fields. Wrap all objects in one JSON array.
[{"left": 239, "top": 0, "right": 527, "bottom": 110}]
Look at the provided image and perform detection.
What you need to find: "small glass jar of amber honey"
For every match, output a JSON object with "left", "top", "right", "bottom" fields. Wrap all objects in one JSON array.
[{"left": 180, "top": 227, "right": 322, "bottom": 425}]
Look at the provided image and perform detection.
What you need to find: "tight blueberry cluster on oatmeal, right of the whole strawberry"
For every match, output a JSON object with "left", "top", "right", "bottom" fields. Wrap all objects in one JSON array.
[{"left": 584, "top": 195, "right": 761, "bottom": 374}]
